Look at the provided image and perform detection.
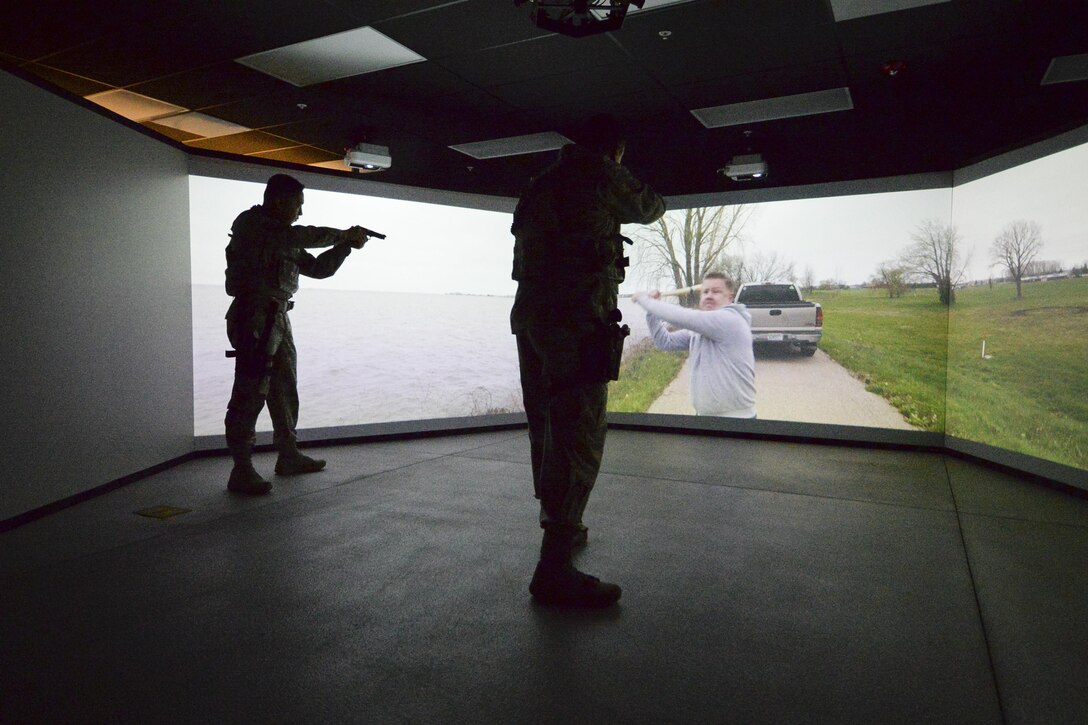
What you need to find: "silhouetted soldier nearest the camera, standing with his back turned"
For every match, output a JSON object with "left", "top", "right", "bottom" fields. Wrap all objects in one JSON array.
[{"left": 510, "top": 115, "right": 665, "bottom": 606}]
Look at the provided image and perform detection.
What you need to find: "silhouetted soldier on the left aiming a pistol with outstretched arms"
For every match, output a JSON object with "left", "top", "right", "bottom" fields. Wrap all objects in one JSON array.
[{"left": 225, "top": 174, "right": 368, "bottom": 494}]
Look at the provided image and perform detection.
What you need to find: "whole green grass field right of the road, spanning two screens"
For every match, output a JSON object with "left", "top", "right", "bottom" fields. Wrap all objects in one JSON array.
[{"left": 811, "top": 278, "right": 1088, "bottom": 468}]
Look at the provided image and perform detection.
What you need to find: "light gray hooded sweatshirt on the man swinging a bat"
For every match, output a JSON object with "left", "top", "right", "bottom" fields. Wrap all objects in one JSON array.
[{"left": 638, "top": 297, "right": 755, "bottom": 418}]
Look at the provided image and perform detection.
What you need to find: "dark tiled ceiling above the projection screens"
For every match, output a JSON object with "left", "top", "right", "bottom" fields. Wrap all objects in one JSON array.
[{"left": 0, "top": 0, "right": 1088, "bottom": 195}]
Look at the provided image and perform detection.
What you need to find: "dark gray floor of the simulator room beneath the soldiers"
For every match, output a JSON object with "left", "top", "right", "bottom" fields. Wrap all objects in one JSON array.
[{"left": 0, "top": 431, "right": 1088, "bottom": 724}]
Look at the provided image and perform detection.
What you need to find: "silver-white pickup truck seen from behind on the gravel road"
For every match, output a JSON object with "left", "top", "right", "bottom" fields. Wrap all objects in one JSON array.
[{"left": 734, "top": 283, "right": 824, "bottom": 355}]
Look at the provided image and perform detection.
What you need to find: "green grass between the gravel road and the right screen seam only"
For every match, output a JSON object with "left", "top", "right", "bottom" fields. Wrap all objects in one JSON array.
[{"left": 806, "top": 290, "right": 949, "bottom": 431}]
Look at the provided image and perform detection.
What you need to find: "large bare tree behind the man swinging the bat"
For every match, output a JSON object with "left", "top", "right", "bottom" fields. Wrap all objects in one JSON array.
[{"left": 638, "top": 204, "right": 752, "bottom": 305}]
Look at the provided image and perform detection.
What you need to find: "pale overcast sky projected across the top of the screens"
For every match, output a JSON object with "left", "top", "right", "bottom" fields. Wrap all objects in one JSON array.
[{"left": 189, "top": 139, "right": 1088, "bottom": 295}]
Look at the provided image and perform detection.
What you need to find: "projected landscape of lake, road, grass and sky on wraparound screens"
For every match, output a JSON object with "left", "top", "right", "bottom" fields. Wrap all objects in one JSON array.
[{"left": 190, "top": 139, "right": 1088, "bottom": 468}]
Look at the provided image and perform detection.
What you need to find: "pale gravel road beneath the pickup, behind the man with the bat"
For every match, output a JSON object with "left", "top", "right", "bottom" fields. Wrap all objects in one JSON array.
[{"left": 650, "top": 351, "right": 914, "bottom": 430}]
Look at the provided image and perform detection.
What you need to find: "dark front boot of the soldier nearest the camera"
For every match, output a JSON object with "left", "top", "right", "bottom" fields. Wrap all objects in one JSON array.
[{"left": 529, "top": 530, "right": 622, "bottom": 609}]
